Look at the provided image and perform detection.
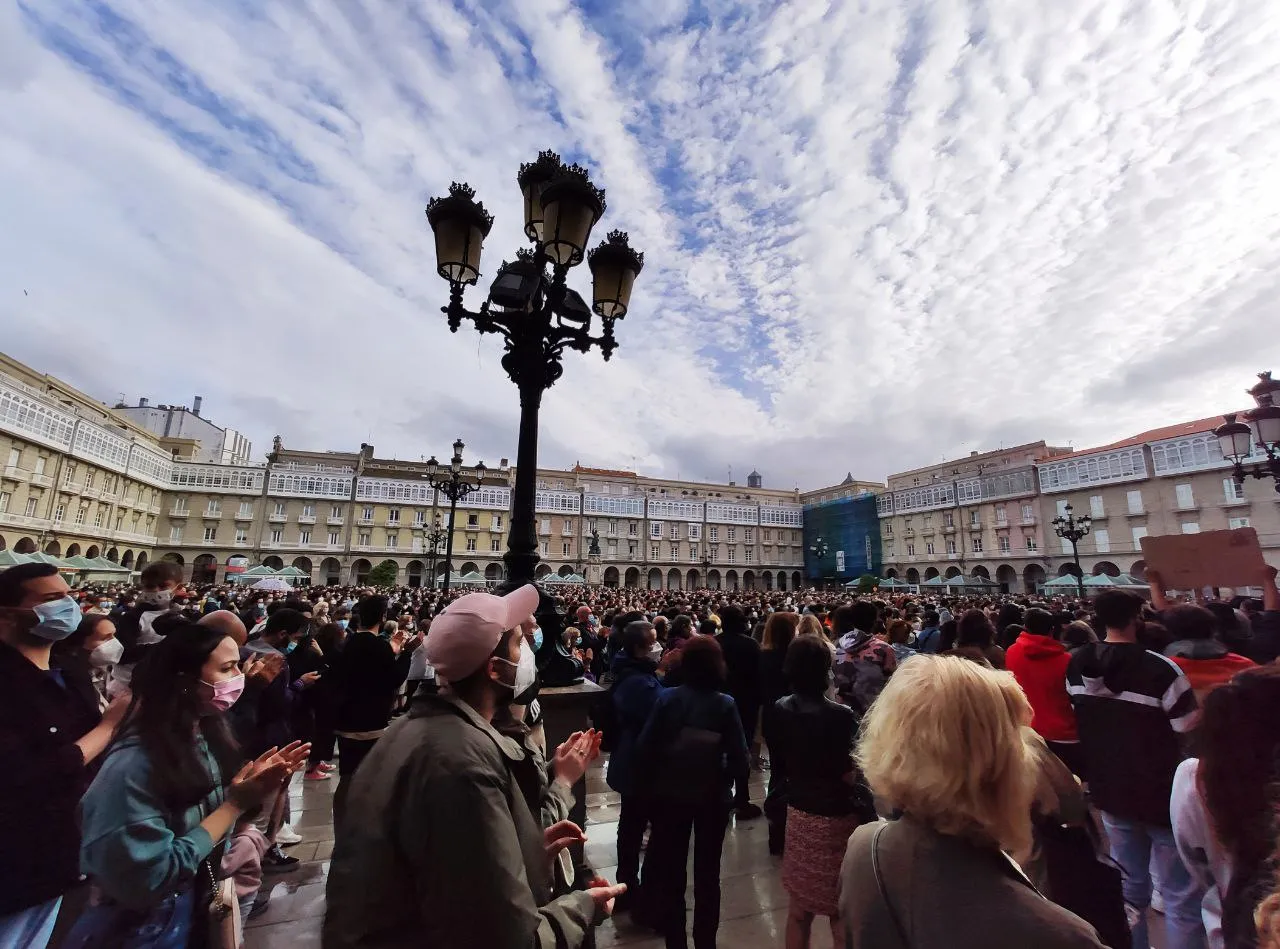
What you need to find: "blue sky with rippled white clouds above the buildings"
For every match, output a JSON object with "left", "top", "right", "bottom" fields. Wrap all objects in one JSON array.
[{"left": 0, "top": 0, "right": 1280, "bottom": 488}]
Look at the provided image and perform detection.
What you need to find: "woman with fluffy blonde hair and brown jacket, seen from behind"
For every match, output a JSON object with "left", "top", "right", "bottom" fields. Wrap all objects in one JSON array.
[{"left": 840, "top": 656, "right": 1102, "bottom": 949}]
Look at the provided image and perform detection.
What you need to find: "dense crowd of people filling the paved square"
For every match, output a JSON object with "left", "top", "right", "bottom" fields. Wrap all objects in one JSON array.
[{"left": 0, "top": 562, "right": 1280, "bottom": 949}]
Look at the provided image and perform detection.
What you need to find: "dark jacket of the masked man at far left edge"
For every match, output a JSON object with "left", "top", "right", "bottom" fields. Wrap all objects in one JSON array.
[{"left": 0, "top": 643, "right": 101, "bottom": 916}]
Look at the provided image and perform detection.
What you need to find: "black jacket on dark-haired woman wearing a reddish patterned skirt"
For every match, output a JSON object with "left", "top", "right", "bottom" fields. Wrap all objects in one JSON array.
[{"left": 769, "top": 695, "right": 876, "bottom": 820}]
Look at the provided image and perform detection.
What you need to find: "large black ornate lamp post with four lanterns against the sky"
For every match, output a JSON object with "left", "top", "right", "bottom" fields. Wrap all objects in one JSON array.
[{"left": 426, "top": 151, "right": 644, "bottom": 663}]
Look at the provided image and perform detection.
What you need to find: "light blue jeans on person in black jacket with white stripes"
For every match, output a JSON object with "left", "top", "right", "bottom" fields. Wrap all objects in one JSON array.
[{"left": 1102, "top": 812, "right": 1206, "bottom": 949}]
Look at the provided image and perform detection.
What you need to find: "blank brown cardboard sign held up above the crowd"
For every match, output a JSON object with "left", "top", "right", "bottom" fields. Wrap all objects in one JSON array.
[{"left": 1139, "top": 528, "right": 1266, "bottom": 590}]
